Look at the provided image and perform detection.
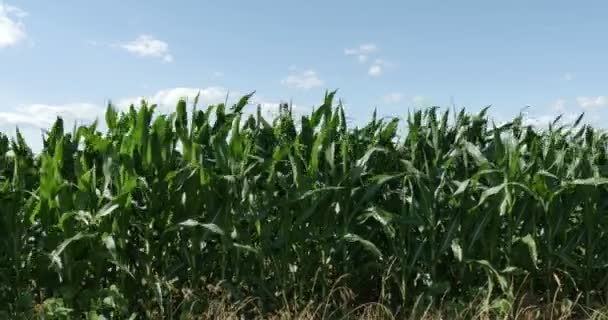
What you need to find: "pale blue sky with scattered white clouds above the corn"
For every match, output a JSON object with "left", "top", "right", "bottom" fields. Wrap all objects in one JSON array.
[{"left": 0, "top": 0, "right": 608, "bottom": 148}]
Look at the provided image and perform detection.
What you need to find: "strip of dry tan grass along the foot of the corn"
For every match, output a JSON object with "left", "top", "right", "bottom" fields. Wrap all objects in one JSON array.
[{"left": 172, "top": 288, "right": 608, "bottom": 320}]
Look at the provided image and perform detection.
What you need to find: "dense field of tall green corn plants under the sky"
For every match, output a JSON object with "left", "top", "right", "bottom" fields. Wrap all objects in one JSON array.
[{"left": 0, "top": 93, "right": 608, "bottom": 319}]
